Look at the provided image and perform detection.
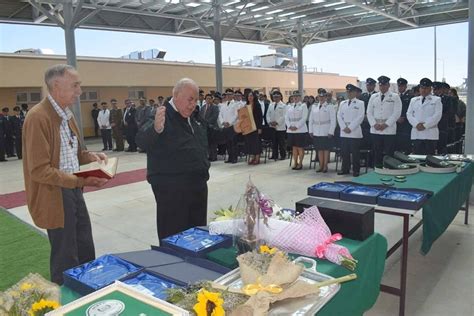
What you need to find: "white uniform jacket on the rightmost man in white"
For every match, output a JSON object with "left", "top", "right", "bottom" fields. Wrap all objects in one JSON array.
[{"left": 407, "top": 95, "right": 443, "bottom": 140}]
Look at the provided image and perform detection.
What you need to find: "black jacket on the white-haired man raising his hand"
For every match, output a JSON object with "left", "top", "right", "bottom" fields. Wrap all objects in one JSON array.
[{"left": 136, "top": 102, "right": 235, "bottom": 185}]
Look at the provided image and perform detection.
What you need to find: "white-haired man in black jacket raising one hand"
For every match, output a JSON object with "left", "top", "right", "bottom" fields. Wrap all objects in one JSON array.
[{"left": 137, "top": 78, "right": 239, "bottom": 239}]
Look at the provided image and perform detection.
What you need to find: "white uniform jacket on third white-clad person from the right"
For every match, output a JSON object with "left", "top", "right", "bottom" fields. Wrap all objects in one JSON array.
[{"left": 337, "top": 98, "right": 365, "bottom": 138}]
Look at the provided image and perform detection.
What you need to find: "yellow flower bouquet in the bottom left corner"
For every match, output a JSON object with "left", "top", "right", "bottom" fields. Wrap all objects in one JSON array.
[{"left": 0, "top": 274, "right": 59, "bottom": 316}]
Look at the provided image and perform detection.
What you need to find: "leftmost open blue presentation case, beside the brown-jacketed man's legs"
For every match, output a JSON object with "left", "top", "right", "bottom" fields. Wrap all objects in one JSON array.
[{"left": 63, "top": 255, "right": 142, "bottom": 295}]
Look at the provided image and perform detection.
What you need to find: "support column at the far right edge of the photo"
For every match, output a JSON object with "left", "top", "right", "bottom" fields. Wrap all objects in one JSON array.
[{"left": 464, "top": 1, "right": 474, "bottom": 154}]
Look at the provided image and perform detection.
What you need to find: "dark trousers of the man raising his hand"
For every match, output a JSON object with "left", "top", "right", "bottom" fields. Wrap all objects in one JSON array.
[{"left": 151, "top": 182, "right": 207, "bottom": 240}]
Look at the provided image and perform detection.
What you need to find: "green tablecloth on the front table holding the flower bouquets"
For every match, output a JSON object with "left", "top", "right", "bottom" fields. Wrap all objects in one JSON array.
[{"left": 61, "top": 234, "right": 387, "bottom": 316}]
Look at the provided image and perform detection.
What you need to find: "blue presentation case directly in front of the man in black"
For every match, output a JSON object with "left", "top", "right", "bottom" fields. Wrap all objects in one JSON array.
[{"left": 160, "top": 227, "right": 232, "bottom": 258}]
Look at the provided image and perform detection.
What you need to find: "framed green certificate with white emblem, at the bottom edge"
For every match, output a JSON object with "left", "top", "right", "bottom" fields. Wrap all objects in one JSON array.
[{"left": 47, "top": 281, "right": 189, "bottom": 316}]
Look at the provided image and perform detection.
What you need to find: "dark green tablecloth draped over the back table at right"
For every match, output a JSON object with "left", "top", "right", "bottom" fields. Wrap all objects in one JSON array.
[{"left": 352, "top": 163, "right": 474, "bottom": 255}]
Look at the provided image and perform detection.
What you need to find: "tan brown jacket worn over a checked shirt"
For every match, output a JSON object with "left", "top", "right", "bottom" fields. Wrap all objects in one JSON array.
[{"left": 22, "top": 98, "right": 90, "bottom": 229}]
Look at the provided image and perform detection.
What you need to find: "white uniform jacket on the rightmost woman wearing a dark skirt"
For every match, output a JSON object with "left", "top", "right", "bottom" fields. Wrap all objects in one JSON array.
[{"left": 308, "top": 102, "right": 336, "bottom": 136}]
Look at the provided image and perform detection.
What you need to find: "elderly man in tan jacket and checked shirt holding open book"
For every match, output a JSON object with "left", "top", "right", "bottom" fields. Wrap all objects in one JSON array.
[{"left": 23, "top": 65, "right": 107, "bottom": 285}]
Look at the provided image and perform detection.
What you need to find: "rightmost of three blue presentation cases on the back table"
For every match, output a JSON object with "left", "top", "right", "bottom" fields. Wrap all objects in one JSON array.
[{"left": 377, "top": 190, "right": 429, "bottom": 210}]
